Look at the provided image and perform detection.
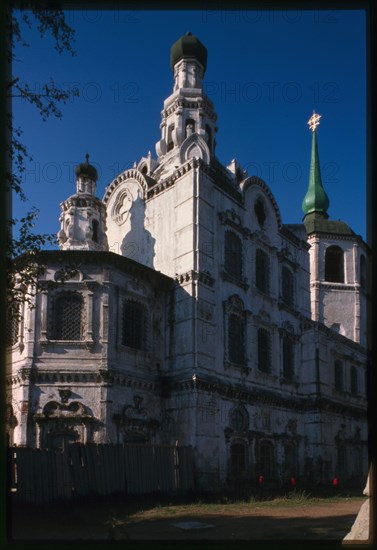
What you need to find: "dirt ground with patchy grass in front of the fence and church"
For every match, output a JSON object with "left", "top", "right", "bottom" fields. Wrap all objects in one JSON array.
[{"left": 11, "top": 498, "right": 364, "bottom": 541}]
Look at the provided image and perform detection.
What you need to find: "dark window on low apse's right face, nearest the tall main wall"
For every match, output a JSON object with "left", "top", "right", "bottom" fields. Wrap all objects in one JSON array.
[{"left": 122, "top": 300, "right": 147, "bottom": 350}]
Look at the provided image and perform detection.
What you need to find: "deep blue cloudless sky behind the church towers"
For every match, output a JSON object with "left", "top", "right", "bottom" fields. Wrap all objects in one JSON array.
[{"left": 13, "top": 4, "right": 366, "bottom": 245}]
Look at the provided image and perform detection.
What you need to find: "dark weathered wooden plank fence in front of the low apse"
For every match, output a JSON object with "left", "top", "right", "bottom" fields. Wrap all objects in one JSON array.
[{"left": 8, "top": 443, "right": 194, "bottom": 504}]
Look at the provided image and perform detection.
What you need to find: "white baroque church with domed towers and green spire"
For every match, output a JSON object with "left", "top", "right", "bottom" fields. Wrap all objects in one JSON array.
[{"left": 6, "top": 33, "right": 369, "bottom": 489}]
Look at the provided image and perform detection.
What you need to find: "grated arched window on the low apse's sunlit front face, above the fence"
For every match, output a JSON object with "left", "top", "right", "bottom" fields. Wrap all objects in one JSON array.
[{"left": 52, "top": 292, "right": 84, "bottom": 340}]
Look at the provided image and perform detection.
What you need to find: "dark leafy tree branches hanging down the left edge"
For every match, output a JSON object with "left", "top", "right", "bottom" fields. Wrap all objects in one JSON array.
[{"left": 6, "top": 3, "right": 78, "bottom": 320}]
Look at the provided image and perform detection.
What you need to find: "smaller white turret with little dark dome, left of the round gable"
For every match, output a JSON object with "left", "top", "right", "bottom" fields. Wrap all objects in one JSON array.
[{"left": 57, "top": 154, "right": 108, "bottom": 250}]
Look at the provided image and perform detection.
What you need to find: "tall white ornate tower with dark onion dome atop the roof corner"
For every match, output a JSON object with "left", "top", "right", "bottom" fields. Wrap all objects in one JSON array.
[{"left": 155, "top": 32, "right": 217, "bottom": 176}]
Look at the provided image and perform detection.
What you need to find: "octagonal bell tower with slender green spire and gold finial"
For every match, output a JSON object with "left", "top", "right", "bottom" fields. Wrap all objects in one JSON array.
[{"left": 302, "top": 112, "right": 369, "bottom": 346}]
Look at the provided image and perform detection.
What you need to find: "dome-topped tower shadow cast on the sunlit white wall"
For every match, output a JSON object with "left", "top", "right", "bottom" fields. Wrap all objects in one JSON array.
[{"left": 120, "top": 195, "right": 156, "bottom": 267}]
